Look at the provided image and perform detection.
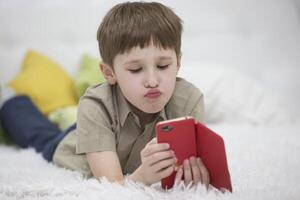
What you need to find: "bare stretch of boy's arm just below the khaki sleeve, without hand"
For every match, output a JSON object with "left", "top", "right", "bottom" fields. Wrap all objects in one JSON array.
[{"left": 86, "top": 151, "right": 124, "bottom": 182}]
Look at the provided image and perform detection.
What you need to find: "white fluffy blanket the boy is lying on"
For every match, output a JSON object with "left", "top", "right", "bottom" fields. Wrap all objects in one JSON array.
[{"left": 0, "top": 124, "right": 300, "bottom": 200}]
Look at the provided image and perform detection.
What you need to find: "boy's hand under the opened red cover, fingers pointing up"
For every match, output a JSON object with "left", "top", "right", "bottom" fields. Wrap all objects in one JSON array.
[{"left": 175, "top": 157, "right": 210, "bottom": 188}]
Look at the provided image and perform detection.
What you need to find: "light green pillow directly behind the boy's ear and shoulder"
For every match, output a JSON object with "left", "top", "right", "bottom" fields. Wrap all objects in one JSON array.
[{"left": 75, "top": 54, "right": 105, "bottom": 100}]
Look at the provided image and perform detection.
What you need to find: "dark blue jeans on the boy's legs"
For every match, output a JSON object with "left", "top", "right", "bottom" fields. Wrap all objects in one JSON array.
[{"left": 0, "top": 96, "right": 76, "bottom": 162}]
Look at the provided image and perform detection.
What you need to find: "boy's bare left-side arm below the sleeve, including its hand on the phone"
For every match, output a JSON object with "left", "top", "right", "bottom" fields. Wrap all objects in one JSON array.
[{"left": 86, "top": 138, "right": 176, "bottom": 185}]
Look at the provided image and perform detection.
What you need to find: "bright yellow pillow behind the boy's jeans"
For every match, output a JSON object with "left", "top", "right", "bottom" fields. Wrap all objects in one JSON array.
[{"left": 9, "top": 51, "right": 76, "bottom": 115}]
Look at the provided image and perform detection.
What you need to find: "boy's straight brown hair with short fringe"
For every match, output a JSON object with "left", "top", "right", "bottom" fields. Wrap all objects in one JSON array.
[{"left": 97, "top": 2, "right": 182, "bottom": 67}]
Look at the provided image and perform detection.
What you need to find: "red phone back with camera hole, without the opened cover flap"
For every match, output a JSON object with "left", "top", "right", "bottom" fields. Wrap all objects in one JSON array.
[{"left": 156, "top": 117, "right": 197, "bottom": 189}]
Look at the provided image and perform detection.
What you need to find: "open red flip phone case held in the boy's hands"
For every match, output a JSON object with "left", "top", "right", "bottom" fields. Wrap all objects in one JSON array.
[{"left": 156, "top": 117, "right": 232, "bottom": 192}]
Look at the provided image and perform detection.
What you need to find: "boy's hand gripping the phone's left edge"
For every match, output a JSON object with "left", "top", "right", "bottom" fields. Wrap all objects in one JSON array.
[{"left": 130, "top": 138, "right": 177, "bottom": 185}]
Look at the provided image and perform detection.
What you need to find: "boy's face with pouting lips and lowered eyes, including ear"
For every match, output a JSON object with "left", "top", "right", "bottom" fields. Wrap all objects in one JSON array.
[{"left": 101, "top": 43, "right": 180, "bottom": 113}]
